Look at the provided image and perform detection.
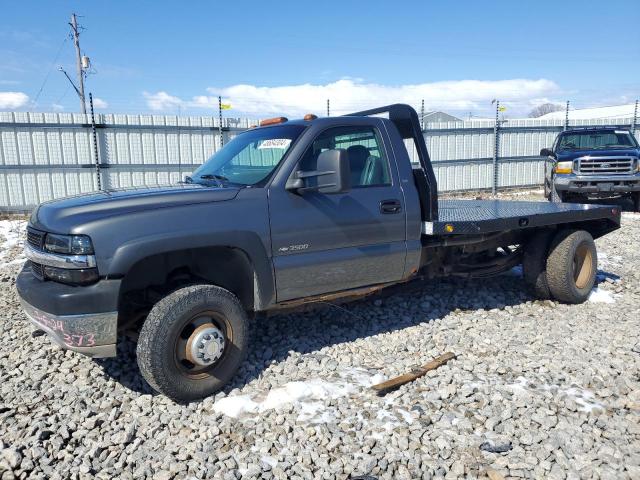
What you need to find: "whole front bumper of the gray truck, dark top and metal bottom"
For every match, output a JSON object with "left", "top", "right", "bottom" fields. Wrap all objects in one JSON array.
[{"left": 16, "top": 266, "right": 120, "bottom": 357}]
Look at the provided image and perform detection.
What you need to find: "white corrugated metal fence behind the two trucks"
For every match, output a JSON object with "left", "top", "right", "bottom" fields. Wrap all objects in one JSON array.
[{"left": 0, "top": 112, "right": 640, "bottom": 212}]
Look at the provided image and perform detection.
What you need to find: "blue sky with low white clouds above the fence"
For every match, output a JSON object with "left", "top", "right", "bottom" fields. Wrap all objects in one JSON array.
[{"left": 0, "top": 0, "right": 640, "bottom": 118}]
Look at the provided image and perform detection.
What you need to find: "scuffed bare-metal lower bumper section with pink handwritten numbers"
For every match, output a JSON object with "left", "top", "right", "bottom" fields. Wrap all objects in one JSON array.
[{"left": 20, "top": 298, "right": 118, "bottom": 358}]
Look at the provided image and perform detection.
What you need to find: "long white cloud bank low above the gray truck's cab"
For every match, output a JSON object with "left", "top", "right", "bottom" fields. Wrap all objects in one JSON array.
[{"left": 145, "top": 78, "right": 560, "bottom": 115}]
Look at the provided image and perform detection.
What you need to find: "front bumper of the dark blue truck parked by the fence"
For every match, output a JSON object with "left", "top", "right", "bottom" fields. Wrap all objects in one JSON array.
[{"left": 553, "top": 173, "right": 640, "bottom": 195}]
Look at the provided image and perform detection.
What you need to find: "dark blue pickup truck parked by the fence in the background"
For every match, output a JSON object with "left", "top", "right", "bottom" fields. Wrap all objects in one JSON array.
[{"left": 540, "top": 127, "right": 640, "bottom": 212}]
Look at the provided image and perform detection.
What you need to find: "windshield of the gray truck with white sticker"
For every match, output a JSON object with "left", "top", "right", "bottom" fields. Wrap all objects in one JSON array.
[{"left": 187, "top": 125, "right": 304, "bottom": 185}]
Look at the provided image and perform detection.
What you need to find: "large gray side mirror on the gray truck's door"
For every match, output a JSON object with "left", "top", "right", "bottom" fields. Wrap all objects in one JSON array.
[{"left": 286, "top": 149, "right": 351, "bottom": 194}]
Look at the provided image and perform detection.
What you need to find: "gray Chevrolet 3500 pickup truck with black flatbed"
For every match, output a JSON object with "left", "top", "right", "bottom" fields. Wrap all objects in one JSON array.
[{"left": 16, "top": 105, "right": 620, "bottom": 401}]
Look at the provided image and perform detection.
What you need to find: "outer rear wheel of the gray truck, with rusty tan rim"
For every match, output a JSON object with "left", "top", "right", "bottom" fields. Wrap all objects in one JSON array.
[{"left": 547, "top": 230, "right": 598, "bottom": 303}]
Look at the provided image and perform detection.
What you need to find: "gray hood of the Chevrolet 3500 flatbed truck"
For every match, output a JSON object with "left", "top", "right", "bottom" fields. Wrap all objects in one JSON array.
[{"left": 31, "top": 184, "right": 240, "bottom": 233}]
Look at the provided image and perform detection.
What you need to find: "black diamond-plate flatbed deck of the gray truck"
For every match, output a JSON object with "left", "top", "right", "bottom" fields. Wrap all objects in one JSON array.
[{"left": 422, "top": 200, "right": 620, "bottom": 236}]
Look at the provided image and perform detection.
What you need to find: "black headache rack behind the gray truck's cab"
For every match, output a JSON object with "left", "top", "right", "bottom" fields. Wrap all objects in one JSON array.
[{"left": 345, "top": 103, "right": 438, "bottom": 222}]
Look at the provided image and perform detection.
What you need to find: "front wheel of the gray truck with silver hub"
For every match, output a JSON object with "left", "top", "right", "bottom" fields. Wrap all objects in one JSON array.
[{"left": 137, "top": 285, "right": 249, "bottom": 401}]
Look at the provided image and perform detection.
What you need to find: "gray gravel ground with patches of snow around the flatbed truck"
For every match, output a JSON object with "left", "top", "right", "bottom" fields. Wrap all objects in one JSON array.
[{"left": 0, "top": 196, "right": 640, "bottom": 480}]
